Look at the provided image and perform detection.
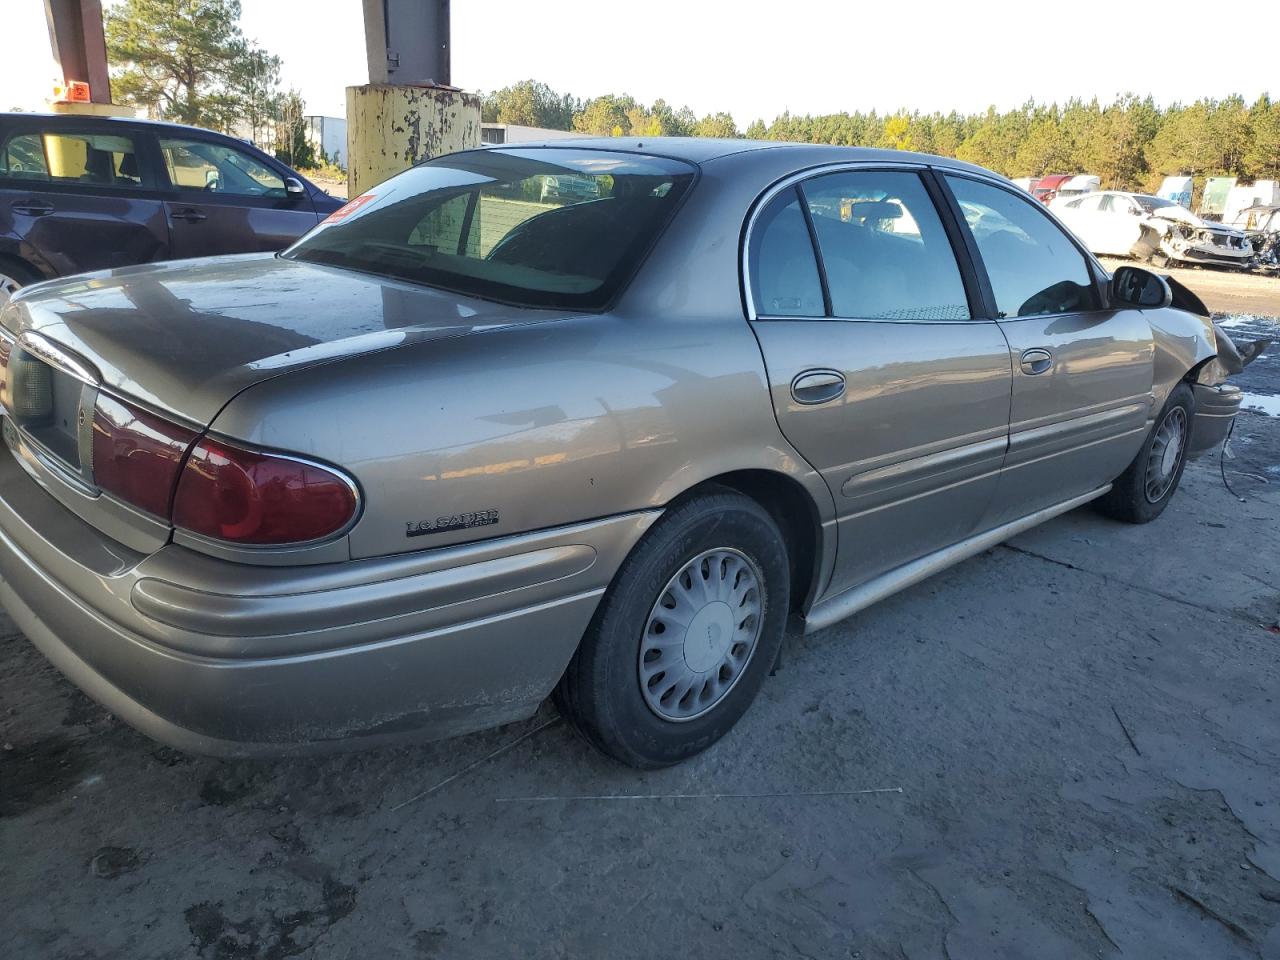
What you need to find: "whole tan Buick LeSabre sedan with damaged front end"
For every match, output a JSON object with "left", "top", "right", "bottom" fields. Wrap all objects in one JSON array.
[{"left": 0, "top": 137, "right": 1259, "bottom": 767}]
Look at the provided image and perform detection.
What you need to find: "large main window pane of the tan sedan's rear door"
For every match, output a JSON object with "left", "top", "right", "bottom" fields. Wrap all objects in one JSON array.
[{"left": 803, "top": 170, "right": 970, "bottom": 320}]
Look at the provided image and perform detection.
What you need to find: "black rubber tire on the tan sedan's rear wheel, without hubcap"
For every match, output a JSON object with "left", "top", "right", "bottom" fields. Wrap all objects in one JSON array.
[{"left": 556, "top": 488, "right": 791, "bottom": 769}]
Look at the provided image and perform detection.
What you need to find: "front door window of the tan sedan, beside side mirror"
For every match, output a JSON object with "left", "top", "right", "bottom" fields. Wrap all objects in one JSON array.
[{"left": 946, "top": 177, "right": 1097, "bottom": 317}]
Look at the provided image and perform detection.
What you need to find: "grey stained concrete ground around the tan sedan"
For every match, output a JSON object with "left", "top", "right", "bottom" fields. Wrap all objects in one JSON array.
[{"left": 0, "top": 312, "right": 1280, "bottom": 960}]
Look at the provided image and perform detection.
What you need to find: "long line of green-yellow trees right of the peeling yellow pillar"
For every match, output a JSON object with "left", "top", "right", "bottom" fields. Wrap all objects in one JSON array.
[{"left": 481, "top": 81, "right": 1280, "bottom": 189}]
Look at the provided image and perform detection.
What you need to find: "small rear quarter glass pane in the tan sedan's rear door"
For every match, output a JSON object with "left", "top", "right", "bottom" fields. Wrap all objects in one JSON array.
[{"left": 748, "top": 189, "right": 826, "bottom": 316}]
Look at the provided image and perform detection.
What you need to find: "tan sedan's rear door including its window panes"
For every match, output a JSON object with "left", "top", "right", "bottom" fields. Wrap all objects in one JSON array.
[{"left": 746, "top": 168, "right": 1011, "bottom": 591}]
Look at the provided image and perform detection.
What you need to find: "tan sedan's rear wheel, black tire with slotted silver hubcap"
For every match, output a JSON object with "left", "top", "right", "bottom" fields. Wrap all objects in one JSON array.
[{"left": 556, "top": 489, "right": 790, "bottom": 768}]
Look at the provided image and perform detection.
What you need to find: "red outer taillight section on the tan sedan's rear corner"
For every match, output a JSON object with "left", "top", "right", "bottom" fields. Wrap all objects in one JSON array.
[{"left": 173, "top": 438, "right": 357, "bottom": 545}]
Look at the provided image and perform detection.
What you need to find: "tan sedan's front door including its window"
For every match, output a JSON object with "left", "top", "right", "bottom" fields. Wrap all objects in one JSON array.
[{"left": 945, "top": 174, "right": 1155, "bottom": 526}]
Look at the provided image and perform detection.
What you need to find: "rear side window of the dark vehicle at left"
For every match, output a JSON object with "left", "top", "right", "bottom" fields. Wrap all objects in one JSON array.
[{"left": 0, "top": 133, "right": 142, "bottom": 188}]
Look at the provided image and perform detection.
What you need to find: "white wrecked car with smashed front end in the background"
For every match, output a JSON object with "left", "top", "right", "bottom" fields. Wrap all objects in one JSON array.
[{"left": 1050, "top": 189, "right": 1254, "bottom": 269}]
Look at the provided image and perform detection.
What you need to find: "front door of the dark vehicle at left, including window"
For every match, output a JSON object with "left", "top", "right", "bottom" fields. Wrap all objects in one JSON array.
[{"left": 159, "top": 133, "right": 317, "bottom": 260}]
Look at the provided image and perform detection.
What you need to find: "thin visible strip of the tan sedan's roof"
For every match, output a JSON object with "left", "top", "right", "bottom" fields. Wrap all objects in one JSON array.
[{"left": 484, "top": 137, "right": 991, "bottom": 177}]
